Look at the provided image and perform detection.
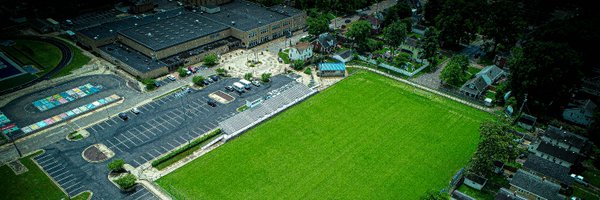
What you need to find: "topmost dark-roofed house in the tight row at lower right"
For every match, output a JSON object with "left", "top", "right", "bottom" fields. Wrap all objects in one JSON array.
[{"left": 540, "top": 126, "right": 588, "bottom": 153}]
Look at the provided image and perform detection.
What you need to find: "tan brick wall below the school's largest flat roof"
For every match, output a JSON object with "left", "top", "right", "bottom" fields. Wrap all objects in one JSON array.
[{"left": 118, "top": 29, "right": 231, "bottom": 59}]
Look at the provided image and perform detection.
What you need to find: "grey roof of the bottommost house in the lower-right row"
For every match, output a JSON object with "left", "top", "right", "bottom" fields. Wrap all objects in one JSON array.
[{"left": 510, "top": 169, "right": 564, "bottom": 200}]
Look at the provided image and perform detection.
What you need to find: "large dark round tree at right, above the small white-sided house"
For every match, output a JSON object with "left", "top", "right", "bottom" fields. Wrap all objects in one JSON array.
[{"left": 508, "top": 41, "right": 583, "bottom": 114}]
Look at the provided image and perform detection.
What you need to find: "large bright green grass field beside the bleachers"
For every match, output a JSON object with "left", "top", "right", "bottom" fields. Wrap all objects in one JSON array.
[{"left": 157, "top": 71, "right": 492, "bottom": 199}]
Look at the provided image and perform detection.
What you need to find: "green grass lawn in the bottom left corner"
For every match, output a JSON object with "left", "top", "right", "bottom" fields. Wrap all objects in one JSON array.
[{"left": 0, "top": 151, "right": 68, "bottom": 200}]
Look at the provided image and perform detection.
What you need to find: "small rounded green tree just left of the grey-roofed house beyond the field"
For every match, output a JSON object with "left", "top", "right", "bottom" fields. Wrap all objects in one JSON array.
[{"left": 440, "top": 55, "right": 469, "bottom": 87}]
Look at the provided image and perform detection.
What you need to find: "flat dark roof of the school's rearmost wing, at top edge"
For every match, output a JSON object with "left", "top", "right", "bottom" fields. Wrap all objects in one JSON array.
[{"left": 201, "top": 0, "right": 289, "bottom": 31}]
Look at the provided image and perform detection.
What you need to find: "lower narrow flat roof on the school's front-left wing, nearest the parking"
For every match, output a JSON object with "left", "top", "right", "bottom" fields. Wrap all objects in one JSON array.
[{"left": 100, "top": 43, "right": 167, "bottom": 73}]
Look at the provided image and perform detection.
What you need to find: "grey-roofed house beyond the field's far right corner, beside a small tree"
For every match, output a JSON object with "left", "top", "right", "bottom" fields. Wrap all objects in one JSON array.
[{"left": 460, "top": 65, "right": 506, "bottom": 98}]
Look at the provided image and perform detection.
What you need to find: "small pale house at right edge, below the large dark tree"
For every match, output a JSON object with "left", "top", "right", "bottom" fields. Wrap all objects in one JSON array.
[{"left": 563, "top": 99, "right": 598, "bottom": 126}]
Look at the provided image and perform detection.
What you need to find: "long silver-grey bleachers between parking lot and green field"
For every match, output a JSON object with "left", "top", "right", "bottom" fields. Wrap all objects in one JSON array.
[{"left": 219, "top": 82, "right": 317, "bottom": 137}]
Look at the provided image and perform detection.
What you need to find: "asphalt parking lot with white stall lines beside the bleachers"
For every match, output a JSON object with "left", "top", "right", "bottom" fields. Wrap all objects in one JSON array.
[{"left": 36, "top": 76, "right": 293, "bottom": 199}]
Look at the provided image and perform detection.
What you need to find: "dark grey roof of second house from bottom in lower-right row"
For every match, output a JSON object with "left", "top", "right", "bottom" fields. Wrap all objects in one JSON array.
[{"left": 523, "top": 154, "right": 573, "bottom": 185}]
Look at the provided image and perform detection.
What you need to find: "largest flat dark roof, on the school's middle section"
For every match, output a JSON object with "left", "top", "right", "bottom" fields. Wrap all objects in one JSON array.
[{"left": 119, "top": 13, "right": 228, "bottom": 51}]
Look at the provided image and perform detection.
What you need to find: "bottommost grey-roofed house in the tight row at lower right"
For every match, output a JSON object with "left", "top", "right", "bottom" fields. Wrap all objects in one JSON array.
[{"left": 510, "top": 169, "right": 566, "bottom": 200}]
